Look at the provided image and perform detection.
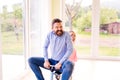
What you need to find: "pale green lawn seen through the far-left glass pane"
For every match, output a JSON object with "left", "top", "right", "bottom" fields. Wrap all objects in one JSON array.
[{"left": 2, "top": 32, "right": 23, "bottom": 55}]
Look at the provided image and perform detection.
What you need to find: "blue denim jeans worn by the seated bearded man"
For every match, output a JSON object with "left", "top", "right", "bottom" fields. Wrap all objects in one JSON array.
[{"left": 28, "top": 57, "right": 74, "bottom": 80}]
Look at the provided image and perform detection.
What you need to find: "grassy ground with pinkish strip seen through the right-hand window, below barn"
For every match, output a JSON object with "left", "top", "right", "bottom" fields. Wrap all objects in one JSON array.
[{"left": 75, "top": 32, "right": 120, "bottom": 56}]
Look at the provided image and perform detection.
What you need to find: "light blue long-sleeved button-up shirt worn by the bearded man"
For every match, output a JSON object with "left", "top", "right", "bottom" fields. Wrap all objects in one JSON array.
[{"left": 43, "top": 31, "right": 73, "bottom": 64}]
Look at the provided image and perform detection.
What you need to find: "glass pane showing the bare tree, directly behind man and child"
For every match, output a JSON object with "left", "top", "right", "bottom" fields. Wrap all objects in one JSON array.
[{"left": 65, "top": 0, "right": 92, "bottom": 56}]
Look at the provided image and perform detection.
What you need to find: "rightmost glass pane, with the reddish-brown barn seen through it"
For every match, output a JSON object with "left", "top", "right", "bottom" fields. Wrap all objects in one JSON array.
[{"left": 99, "top": 0, "right": 120, "bottom": 57}]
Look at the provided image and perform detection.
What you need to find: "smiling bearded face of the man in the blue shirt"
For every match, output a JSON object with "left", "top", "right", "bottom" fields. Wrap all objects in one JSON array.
[{"left": 52, "top": 23, "right": 63, "bottom": 36}]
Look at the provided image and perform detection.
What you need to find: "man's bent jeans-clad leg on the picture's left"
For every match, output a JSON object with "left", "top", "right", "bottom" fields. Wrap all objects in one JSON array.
[{"left": 28, "top": 57, "right": 44, "bottom": 80}]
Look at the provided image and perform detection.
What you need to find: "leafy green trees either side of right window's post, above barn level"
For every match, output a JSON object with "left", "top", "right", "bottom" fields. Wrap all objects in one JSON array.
[{"left": 74, "top": 8, "right": 119, "bottom": 31}]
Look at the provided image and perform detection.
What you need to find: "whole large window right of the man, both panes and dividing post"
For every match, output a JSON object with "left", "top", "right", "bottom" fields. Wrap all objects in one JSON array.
[{"left": 65, "top": 0, "right": 120, "bottom": 58}]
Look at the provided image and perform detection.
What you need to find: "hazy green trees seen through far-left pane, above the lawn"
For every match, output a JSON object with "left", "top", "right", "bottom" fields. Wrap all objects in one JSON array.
[{"left": 0, "top": 4, "right": 22, "bottom": 32}]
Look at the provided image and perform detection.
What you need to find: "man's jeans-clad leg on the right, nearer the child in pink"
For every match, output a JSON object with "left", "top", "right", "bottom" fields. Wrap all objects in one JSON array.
[{"left": 61, "top": 61, "right": 74, "bottom": 80}]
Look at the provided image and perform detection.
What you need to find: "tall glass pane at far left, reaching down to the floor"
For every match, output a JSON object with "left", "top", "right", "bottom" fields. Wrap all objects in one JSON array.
[{"left": 0, "top": 0, "right": 24, "bottom": 80}]
